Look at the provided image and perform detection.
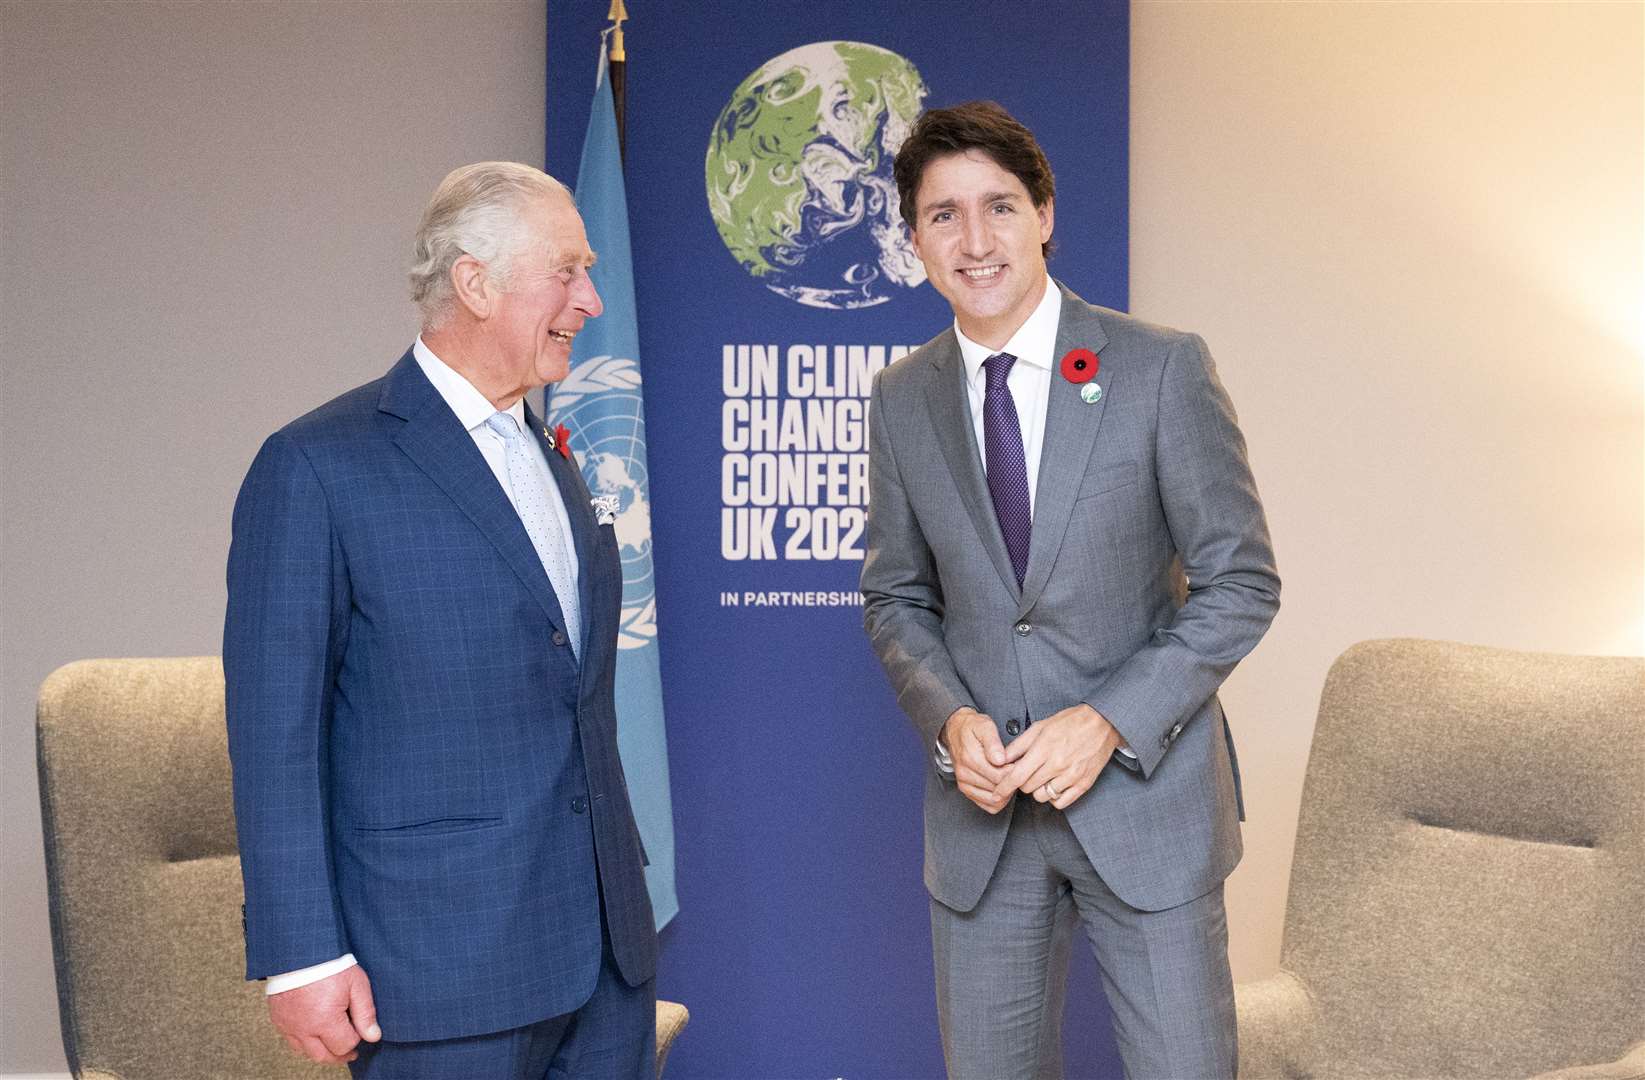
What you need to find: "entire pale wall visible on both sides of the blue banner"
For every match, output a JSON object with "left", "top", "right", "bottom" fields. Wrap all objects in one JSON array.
[{"left": 0, "top": 0, "right": 1645, "bottom": 1073}]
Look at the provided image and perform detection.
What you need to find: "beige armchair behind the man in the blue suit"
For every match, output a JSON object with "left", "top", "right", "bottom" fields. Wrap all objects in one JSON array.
[{"left": 38, "top": 658, "right": 688, "bottom": 1080}]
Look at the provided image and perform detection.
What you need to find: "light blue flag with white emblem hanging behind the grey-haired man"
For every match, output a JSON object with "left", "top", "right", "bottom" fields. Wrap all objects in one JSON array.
[{"left": 544, "top": 49, "right": 679, "bottom": 929}]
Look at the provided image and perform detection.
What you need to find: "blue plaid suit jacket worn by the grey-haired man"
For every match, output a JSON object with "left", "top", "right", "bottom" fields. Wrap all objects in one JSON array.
[{"left": 224, "top": 352, "right": 656, "bottom": 1041}]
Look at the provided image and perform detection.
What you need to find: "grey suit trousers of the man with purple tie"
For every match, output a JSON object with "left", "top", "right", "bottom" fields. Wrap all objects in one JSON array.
[{"left": 931, "top": 795, "right": 1235, "bottom": 1080}]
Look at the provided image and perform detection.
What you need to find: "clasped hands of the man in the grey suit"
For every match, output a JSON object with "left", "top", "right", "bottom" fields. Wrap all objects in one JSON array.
[{"left": 943, "top": 702, "right": 1125, "bottom": 814}]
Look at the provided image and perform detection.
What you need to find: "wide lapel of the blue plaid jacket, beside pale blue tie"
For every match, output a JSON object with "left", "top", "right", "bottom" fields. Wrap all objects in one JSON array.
[{"left": 377, "top": 352, "right": 576, "bottom": 631}]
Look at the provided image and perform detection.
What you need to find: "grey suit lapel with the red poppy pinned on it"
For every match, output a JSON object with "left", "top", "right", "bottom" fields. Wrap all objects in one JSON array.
[{"left": 1018, "top": 289, "right": 1120, "bottom": 618}]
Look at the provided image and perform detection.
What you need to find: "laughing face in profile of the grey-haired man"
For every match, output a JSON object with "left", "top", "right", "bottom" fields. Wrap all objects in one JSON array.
[{"left": 485, "top": 194, "right": 604, "bottom": 399}]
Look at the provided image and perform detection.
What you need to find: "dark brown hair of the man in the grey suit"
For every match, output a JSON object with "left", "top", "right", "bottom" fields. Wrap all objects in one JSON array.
[{"left": 892, "top": 102, "right": 1056, "bottom": 255}]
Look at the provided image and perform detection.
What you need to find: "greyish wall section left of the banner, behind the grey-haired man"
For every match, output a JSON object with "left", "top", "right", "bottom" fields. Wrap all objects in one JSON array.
[{"left": 0, "top": 0, "right": 544, "bottom": 1073}]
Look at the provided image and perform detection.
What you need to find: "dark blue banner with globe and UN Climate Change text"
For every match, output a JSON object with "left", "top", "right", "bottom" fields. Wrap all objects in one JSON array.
[{"left": 546, "top": 0, "right": 1128, "bottom": 1080}]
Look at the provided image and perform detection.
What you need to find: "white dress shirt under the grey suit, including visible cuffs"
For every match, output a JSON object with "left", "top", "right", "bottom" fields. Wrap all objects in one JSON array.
[{"left": 934, "top": 275, "right": 1137, "bottom": 773}]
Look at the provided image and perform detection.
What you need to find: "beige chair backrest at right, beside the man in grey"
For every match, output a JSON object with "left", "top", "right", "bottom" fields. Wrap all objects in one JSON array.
[{"left": 1281, "top": 639, "right": 1645, "bottom": 1077}]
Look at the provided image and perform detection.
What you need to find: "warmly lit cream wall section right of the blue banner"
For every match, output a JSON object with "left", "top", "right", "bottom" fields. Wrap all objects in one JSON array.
[{"left": 1132, "top": 2, "right": 1645, "bottom": 980}]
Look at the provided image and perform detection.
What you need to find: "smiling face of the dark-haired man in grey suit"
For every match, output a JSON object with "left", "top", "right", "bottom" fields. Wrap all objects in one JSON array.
[{"left": 913, "top": 150, "right": 1053, "bottom": 348}]
